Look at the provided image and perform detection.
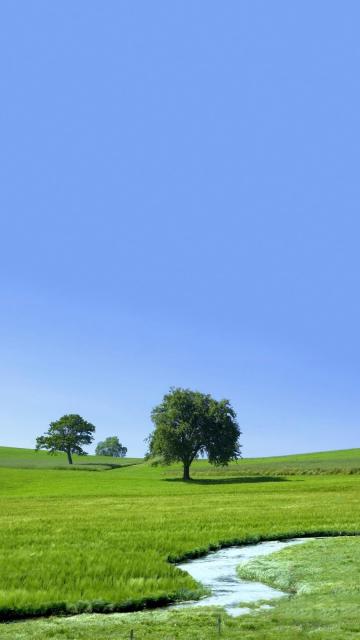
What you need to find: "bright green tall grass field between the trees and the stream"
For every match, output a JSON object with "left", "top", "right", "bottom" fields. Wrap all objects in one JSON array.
[{"left": 0, "top": 444, "right": 360, "bottom": 619}]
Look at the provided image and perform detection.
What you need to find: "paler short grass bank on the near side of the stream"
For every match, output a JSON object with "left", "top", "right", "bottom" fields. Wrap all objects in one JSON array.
[{"left": 0, "top": 537, "right": 360, "bottom": 640}]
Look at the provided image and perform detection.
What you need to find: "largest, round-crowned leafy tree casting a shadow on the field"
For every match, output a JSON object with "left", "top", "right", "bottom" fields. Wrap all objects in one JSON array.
[{"left": 149, "top": 388, "right": 241, "bottom": 480}]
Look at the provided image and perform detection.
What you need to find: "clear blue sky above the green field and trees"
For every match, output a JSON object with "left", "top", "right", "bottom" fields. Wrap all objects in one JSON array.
[{"left": 0, "top": 0, "right": 360, "bottom": 456}]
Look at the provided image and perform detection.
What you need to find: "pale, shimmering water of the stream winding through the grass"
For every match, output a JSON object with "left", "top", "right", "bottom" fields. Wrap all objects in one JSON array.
[{"left": 177, "top": 538, "right": 310, "bottom": 616}]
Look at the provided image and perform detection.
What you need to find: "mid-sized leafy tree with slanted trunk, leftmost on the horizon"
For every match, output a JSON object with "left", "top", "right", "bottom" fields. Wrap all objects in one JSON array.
[{"left": 36, "top": 413, "right": 95, "bottom": 464}]
